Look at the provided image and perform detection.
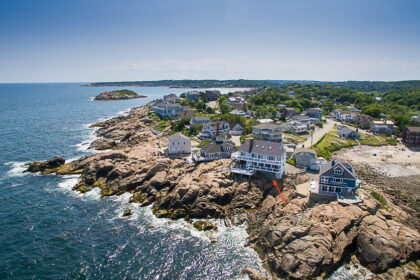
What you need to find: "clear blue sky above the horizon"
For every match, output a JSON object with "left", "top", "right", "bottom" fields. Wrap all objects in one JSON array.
[{"left": 0, "top": 0, "right": 420, "bottom": 83}]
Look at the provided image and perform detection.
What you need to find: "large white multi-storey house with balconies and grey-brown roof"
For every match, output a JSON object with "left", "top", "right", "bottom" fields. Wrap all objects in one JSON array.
[{"left": 231, "top": 139, "right": 286, "bottom": 179}]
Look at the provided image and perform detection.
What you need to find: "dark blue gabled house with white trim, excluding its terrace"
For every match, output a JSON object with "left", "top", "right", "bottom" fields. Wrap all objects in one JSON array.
[{"left": 318, "top": 160, "right": 360, "bottom": 198}]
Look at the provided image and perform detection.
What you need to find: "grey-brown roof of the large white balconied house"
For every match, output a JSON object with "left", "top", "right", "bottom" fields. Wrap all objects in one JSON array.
[{"left": 238, "top": 139, "right": 285, "bottom": 157}]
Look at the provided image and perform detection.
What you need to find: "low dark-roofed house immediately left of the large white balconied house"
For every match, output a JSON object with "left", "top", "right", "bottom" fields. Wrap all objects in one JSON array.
[{"left": 193, "top": 140, "right": 235, "bottom": 162}]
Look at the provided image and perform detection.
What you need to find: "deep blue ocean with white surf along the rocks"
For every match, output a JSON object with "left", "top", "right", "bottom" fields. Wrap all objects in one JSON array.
[{"left": 0, "top": 83, "right": 360, "bottom": 279}]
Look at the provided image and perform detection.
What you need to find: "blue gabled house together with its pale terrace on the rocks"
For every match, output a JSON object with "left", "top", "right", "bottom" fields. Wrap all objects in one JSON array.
[{"left": 311, "top": 160, "right": 362, "bottom": 204}]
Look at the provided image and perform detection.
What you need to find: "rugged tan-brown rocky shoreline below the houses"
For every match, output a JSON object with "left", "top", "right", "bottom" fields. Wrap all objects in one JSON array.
[{"left": 28, "top": 105, "right": 420, "bottom": 279}]
